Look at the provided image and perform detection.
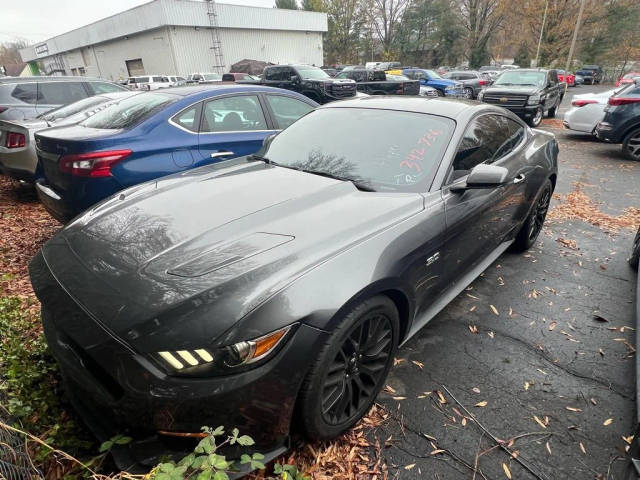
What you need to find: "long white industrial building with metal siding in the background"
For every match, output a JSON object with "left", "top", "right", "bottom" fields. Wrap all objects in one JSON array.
[{"left": 20, "top": 0, "right": 327, "bottom": 80}]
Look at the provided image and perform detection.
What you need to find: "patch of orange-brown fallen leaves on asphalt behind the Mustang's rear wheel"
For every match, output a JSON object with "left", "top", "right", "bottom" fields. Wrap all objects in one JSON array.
[{"left": 547, "top": 182, "right": 640, "bottom": 233}]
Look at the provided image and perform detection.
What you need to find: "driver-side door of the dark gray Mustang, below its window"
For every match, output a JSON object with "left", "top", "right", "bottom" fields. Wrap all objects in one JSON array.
[{"left": 441, "top": 114, "right": 517, "bottom": 283}]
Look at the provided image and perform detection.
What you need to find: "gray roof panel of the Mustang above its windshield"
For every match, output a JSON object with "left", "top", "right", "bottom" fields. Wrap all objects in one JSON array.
[{"left": 319, "top": 95, "right": 502, "bottom": 119}]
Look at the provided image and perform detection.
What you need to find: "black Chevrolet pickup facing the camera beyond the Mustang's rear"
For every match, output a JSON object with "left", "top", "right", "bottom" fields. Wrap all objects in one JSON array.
[{"left": 478, "top": 68, "right": 565, "bottom": 127}]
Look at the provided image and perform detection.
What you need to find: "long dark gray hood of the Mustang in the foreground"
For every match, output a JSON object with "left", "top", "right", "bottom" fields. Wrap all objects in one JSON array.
[{"left": 42, "top": 159, "right": 423, "bottom": 351}]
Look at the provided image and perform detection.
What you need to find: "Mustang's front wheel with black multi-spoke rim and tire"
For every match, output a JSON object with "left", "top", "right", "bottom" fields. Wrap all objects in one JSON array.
[{"left": 297, "top": 295, "right": 400, "bottom": 440}]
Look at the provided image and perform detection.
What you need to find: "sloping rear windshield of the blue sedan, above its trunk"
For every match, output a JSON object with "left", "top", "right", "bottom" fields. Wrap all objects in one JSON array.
[{"left": 81, "top": 92, "right": 179, "bottom": 129}]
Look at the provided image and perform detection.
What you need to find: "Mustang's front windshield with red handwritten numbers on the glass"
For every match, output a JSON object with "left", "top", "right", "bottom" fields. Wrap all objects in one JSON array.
[{"left": 264, "top": 108, "right": 455, "bottom": 192}]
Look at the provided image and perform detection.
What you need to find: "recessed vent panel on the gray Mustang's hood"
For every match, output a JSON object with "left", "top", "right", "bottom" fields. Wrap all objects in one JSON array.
[{"left": 167, "top": 232, "right": 295, "bottom": 277}]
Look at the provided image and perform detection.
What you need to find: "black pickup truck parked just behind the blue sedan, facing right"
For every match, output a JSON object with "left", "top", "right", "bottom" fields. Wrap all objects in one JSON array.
[{"left": 262, "top": 65, "right": 356, "bottom": 104}]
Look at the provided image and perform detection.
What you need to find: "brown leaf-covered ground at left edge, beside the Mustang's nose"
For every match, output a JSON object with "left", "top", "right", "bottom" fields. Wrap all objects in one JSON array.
[{"left": 0, "top": 176, "right": 61, "bottom": 297}]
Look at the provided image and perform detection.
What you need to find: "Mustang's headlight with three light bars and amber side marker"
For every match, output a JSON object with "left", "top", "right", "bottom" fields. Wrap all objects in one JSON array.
[{"left": 155, "top": 325, "right": 293, "bottom": 376}]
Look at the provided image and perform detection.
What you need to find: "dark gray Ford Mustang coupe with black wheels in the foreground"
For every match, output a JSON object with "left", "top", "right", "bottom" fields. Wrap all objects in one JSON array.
[{"left": 30, "top": 97, "right": 558, "bottom": 467}]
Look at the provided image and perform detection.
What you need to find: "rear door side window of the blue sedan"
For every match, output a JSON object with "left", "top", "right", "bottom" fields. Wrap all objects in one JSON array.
[{"left": 200, "top": 95, "right": 267, "bottom": 132}]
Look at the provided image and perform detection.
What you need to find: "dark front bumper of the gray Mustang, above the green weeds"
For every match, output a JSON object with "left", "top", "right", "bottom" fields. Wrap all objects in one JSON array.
[{"left": 29, "top": 253, "right": 328, "bottom": 469}]
